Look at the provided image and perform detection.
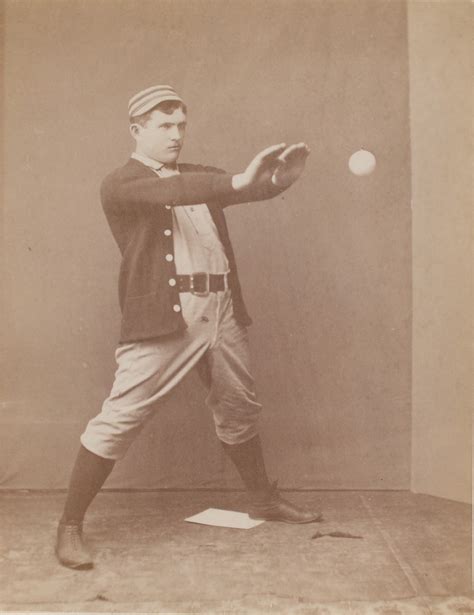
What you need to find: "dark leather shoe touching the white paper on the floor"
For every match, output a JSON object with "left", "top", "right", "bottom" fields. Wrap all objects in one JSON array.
[{"left": 248, "top": 483, "right": 323, "bottom": 523}]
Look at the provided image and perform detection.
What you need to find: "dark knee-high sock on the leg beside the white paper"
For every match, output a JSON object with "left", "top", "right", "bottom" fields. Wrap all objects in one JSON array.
[{"left": 222, "top": 435, "right": 270, "bottom": 491}]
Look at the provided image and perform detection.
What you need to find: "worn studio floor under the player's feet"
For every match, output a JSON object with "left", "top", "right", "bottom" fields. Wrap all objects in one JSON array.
[{"left": 0, "top": 491, "right": 474, "bottom": 615}]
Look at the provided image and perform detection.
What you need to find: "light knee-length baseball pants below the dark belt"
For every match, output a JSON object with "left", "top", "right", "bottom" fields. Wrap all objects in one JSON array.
[{"left": 81, "top": 291, "right": 262, "bottom": 459}]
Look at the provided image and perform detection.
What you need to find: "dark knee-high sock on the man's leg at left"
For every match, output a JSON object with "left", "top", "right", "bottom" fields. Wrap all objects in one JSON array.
[{"left": 61, "top": 445, "right": 115, "bottom": 523}]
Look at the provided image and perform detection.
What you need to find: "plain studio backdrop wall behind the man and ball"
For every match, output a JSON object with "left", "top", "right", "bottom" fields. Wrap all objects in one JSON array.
[{"left": 0, "top": 0, "right": 411, "bottom": 489}]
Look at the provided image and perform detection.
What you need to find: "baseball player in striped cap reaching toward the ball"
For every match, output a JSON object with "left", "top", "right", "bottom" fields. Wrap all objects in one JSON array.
[{"left": 56, "top": 85, "right": 320, "bottom": 569}]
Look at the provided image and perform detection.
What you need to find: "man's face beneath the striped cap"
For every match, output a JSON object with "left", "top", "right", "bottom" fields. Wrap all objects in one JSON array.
[{"left": 130, "top": 108, "right": 186, "bottom": 164}]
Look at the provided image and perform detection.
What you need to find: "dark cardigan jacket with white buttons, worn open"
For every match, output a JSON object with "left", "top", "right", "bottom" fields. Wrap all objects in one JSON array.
[{"left": 101, "top": 158, "right": 282, "bottom": 342}]
